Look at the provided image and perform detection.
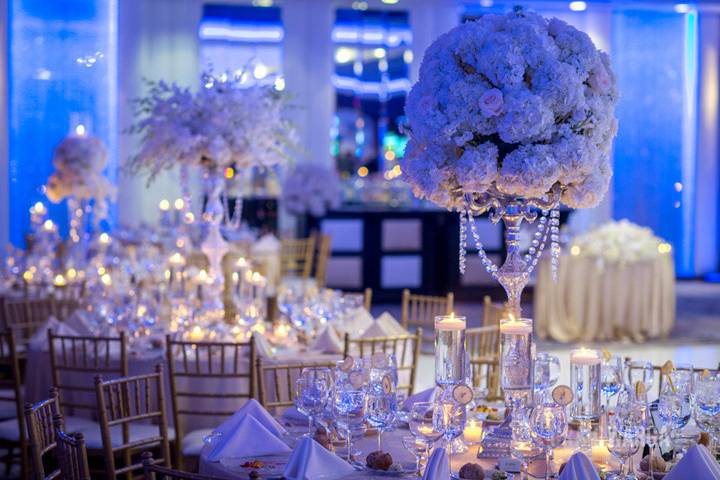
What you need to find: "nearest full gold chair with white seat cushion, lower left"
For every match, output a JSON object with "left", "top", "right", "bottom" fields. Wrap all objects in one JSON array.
[{"left": 95, "top": 364, "right": 171, "bottom": 480}]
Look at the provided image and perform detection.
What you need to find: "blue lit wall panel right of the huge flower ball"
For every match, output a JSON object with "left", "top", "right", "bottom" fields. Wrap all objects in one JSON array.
[{"left": 612, "top": 11, "right": 695, "bottom": 274}]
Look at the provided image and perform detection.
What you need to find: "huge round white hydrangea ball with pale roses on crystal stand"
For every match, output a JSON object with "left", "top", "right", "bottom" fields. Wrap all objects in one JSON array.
[{"left": 403, "top": 9, "right": 618, "bottom": 209}]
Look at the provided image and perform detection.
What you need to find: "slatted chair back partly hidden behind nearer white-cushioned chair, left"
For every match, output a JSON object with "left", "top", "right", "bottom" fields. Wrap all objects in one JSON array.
[{"left": 48, "top": 331, "right": 128, "bottom": 415}]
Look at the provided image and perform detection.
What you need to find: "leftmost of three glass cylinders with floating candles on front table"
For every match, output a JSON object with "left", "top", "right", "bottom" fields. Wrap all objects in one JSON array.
[{"left": 435, "top": 314, "right": 467, "bottom": 387}]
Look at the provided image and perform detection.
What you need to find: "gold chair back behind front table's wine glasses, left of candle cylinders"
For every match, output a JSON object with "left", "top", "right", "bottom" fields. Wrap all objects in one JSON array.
[{"left": 343, "top": 328, "right": 423, "bottom": 396}]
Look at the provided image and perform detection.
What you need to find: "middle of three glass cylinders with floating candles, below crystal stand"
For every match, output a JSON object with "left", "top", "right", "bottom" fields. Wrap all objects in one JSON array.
[{"left": 500, "top": 316, "right": 535, "bottom": 392}]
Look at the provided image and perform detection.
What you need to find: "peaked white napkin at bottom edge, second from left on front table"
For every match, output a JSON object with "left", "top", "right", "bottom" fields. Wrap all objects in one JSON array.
[{"left": 283, "top": 437, "right": 358, "bottom": 480}]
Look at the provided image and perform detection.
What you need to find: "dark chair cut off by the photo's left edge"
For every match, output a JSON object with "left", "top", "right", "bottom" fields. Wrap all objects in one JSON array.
[{"left": 0, "top": 330, "right": 30, "bottom": 479}]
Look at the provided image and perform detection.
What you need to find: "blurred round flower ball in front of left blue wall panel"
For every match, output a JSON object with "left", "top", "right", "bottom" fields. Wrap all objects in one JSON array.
[{"left": 45, "top": 134, "right": 116, "bottom": 220}]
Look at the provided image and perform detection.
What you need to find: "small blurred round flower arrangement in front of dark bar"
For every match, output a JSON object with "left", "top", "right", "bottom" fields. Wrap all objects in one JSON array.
[{"left": 282, "top": 164, "right": 341, "bottom": 217}]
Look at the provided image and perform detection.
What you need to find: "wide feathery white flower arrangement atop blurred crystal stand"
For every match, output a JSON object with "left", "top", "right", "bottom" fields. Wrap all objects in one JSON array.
[{"left": 129, "top": 73, "right": 294, "bottom": 182}]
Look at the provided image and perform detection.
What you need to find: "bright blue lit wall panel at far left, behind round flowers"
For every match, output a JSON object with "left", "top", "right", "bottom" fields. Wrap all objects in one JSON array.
[{"left": 9, "top": 0, "right": 117, "bottom": 245}]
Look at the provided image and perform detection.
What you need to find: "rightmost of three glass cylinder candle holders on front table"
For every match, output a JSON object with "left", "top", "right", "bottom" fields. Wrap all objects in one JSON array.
[{"left": 570, "top": 348, "right": 602, "bottom": 452}]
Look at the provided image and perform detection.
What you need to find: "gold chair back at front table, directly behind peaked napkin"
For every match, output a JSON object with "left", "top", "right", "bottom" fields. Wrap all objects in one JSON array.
[{"left": 256, "top": 358, "right": 335, "bottom": 413}]
